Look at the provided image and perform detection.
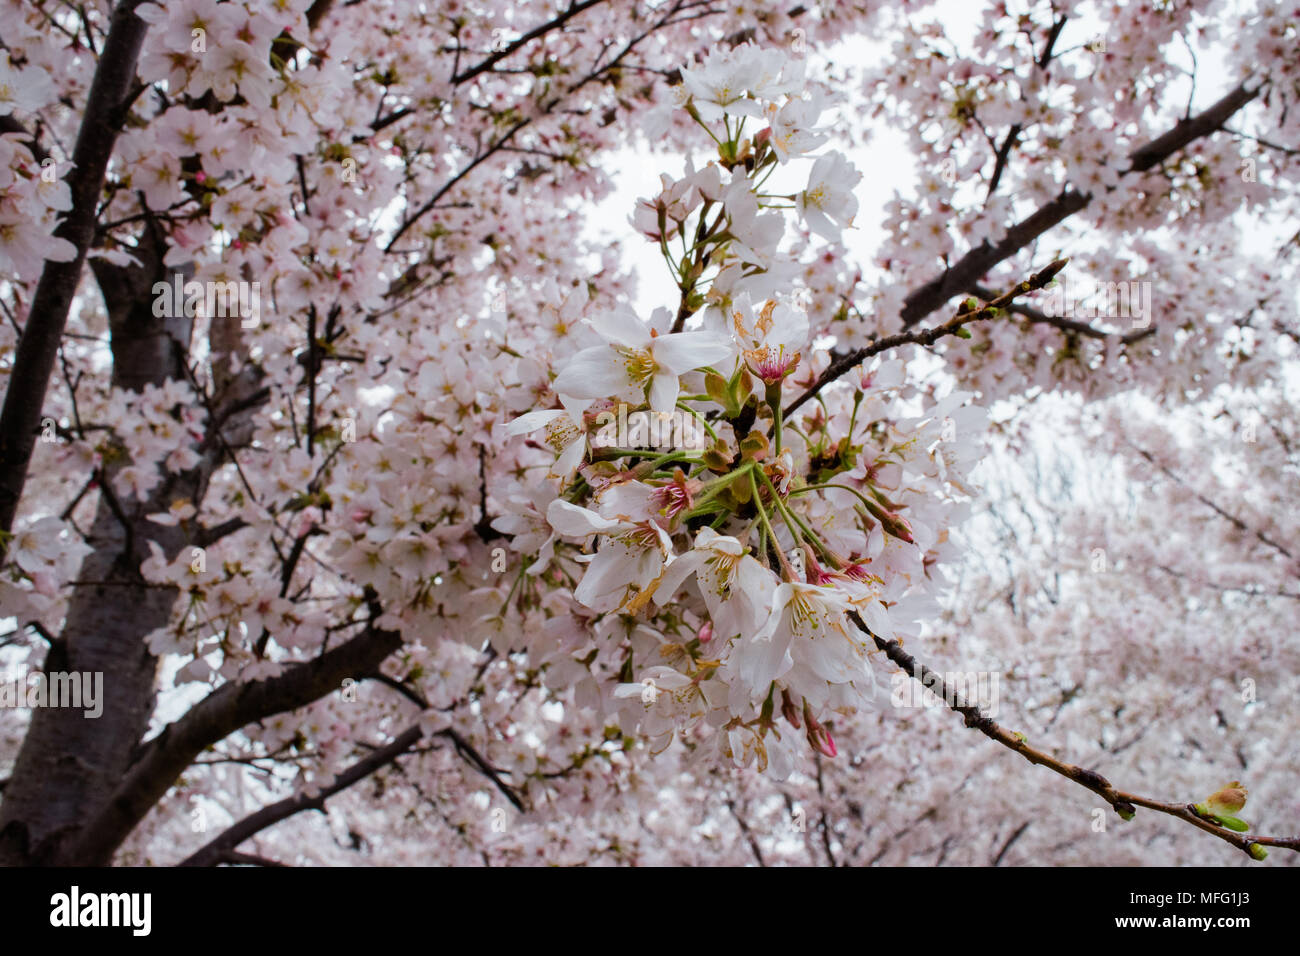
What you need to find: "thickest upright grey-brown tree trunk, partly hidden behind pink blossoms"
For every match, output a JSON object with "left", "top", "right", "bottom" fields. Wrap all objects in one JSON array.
[{"left": 0, "top": 234, "right": 200, "bottom": 865}]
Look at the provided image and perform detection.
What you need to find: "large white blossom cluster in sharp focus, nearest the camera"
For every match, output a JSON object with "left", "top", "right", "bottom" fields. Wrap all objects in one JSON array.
[{"left": 495, "top": 44, "right": 983, "bottom": 778}]
